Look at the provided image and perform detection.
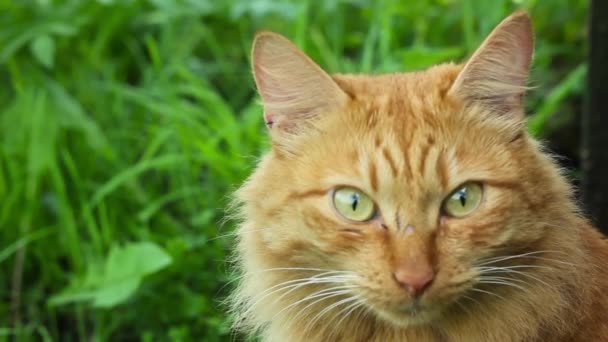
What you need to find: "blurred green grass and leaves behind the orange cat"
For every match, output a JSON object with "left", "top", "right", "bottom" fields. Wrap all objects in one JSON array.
[{"left": 0, "top": 0, "right": 588, "bottom": 341}]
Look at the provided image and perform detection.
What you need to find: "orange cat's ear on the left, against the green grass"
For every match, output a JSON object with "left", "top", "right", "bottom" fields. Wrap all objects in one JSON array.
[{"left": 251, "top": 32, "right": 348, "bottom": 142}]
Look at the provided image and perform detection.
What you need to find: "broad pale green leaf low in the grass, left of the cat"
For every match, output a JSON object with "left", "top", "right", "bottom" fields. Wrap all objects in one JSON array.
[{"left": 49, "top": 242, "right": 171, "bottom": 308}]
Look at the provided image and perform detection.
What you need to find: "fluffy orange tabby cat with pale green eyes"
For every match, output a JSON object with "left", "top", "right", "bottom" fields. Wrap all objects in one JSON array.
[{"left": 231, "top": 11, "right": 608, "bottom": 342}]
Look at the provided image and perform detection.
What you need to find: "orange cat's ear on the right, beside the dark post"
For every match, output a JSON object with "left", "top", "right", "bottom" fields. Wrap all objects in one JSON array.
[{"left": 450, "top": 11, "right": 534, "bottom": 116}]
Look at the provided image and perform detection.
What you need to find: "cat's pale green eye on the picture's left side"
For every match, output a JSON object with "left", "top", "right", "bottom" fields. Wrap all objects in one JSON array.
[{"left": 333, "top": 188, "right": 376, "bottom": 222}]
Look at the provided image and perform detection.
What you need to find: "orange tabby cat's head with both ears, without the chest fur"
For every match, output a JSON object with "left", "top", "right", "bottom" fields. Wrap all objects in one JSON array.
[{"left": 239, "top": 12, "right": 568, "bottom": 325}]
